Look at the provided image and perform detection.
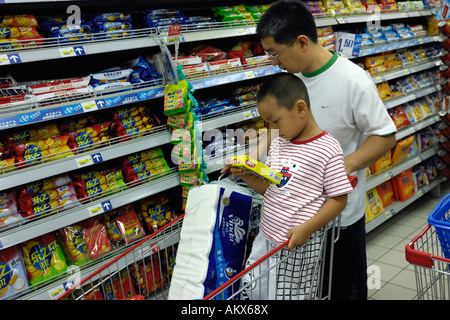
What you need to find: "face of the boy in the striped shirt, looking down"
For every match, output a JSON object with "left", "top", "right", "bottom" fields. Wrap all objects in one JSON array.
[{"left": 258, "top": 96, "right": 307, "bottom": 140}]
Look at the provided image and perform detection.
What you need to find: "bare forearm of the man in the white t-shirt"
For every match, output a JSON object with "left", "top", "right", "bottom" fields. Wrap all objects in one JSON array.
[{"left": 344, "top": 134, "right": 397, "bottom": 175}]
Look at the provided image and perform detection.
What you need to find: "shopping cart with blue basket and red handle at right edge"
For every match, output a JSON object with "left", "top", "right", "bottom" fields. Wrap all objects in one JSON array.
[{"left": 405, "top": 195, "right": 450, "bottom": 300}]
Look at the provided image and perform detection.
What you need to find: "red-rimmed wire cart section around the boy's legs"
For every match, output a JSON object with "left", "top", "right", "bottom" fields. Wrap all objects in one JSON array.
[{"left": 203, "top": 218, "right": 340, "bottom": 300}]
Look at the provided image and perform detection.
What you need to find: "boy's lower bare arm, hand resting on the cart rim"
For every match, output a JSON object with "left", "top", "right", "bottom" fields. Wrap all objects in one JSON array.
[{"left": 286, "top": 194, "right": 347, "bottom": 250}]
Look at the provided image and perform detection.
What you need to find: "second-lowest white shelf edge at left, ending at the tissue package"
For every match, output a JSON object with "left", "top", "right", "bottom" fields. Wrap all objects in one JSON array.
[{"left": 0, "top": 170, "right": 180, "bottom": 249}]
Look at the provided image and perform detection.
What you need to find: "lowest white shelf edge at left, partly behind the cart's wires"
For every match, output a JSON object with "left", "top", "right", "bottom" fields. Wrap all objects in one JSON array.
[{"left": 22, "top": 220, "right": 182, "bottom": 300}]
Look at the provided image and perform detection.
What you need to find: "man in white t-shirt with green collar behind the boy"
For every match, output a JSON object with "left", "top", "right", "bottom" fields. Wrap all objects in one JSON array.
[{"left": 257, "top": 0, "right": 396, "bottom": 300}]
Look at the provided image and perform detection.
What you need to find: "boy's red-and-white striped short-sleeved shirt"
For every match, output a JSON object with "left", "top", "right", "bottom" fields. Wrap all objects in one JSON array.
[{"left": 260, "top": 131, "right": 353, "bottom": 242}]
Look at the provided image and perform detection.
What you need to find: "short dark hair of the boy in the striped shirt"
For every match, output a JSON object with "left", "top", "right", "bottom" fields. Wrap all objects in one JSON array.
[{"left": 256, "top": 72, "right": 310, "bottom": 110}]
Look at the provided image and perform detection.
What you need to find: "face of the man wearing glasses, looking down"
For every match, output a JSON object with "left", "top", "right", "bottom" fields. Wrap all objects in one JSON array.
[{"left": 261, "top": 36, "right": 305, "bottom": 73}]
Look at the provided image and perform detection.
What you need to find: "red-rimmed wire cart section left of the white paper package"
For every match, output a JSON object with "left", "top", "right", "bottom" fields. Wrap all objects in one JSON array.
[{"left": 57, "top": 215, "right": 184, "bottom": 300}]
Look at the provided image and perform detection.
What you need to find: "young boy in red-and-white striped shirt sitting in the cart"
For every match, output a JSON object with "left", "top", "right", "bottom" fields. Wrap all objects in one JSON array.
[{"left": 221, "top": 73, "right": 353, "bottom": 299}]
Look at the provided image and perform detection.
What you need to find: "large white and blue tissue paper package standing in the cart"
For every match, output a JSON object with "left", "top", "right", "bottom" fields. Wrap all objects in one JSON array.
[{"left": 169, "top": 180, "right": 252, "bottom": 300}]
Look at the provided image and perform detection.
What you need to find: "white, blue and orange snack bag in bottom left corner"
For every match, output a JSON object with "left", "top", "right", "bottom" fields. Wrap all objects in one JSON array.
[{"left": 0, "top": 246, "right": 29, "bottom": 300}]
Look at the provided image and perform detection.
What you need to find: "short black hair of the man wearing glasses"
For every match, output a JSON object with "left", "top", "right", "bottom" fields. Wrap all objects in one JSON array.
[{"left": 256, "top": 0, "right": 318, "bottom": 45}]
